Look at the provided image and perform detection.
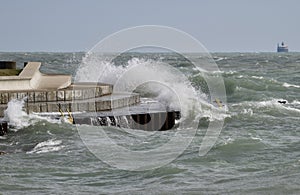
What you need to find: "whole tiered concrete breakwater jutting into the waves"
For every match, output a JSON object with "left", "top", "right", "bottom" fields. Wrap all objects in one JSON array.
[{"left": 0, "top": 62, "right": 180, "bottom": 131}]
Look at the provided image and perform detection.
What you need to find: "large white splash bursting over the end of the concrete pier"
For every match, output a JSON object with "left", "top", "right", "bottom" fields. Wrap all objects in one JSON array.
[{"left": 75, "top": 54, "right": 223, "bottom": 121}]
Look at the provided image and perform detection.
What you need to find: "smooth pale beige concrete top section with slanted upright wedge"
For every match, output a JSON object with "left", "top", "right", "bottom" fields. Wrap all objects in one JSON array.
[{"left": 0, "top": 62, "right": 71, "bottom": 91}]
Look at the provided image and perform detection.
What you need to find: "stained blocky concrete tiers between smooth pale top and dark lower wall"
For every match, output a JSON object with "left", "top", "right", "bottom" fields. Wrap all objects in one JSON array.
[{"left": 0, "top": 83, "right": 140, "bottom": 117}]
